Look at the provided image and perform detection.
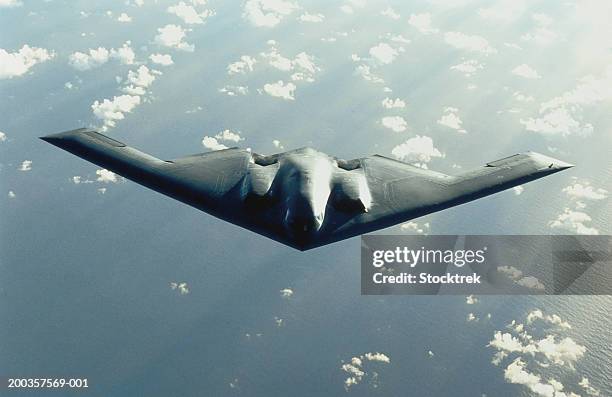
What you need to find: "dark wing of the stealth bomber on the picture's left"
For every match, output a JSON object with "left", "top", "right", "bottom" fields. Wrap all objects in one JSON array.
[{"left": 41, "top": 128, "right": 291, "bottom": 245}]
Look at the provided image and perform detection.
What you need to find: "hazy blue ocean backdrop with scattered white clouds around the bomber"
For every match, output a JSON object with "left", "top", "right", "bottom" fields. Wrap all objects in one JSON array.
[{"left": 0, "top": 0, "right": 612, "bottom": 397}]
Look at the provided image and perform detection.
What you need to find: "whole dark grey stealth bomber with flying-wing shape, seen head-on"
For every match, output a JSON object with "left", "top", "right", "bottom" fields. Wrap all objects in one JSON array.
[{"left": 41, "top": 128, "right": 572, "bottom": 250}]
